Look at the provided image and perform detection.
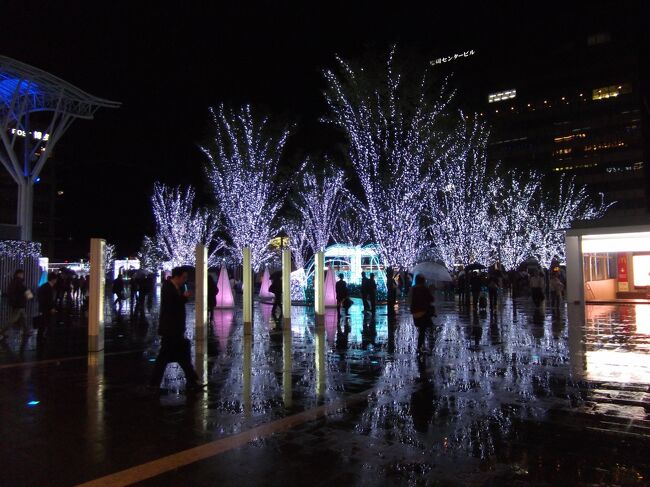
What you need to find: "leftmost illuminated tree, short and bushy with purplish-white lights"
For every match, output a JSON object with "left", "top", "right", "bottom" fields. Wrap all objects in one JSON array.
[{"left": 151, "top": 183, "right": 222, "bottom": 267}]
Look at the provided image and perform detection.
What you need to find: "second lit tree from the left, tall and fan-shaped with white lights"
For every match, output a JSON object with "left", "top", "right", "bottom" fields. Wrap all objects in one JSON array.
[{"left": 202, "top": 105, "right": 288, "bottom": 270}]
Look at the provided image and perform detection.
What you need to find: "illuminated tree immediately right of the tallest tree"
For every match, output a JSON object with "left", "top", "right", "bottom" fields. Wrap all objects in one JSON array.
[{"left": 427, "top": 116, "right": 503, "bottom": 269}]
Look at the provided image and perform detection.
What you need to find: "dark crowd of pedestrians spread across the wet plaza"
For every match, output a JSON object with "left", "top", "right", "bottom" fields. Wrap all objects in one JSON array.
[{"left": 0, "top": 266, "right": 565, "bottom": 392}]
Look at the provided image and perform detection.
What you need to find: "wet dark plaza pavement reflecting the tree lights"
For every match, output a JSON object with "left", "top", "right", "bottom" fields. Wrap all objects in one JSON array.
[{"left": 0, "top": 292, "right": 650, "bottom": 486}]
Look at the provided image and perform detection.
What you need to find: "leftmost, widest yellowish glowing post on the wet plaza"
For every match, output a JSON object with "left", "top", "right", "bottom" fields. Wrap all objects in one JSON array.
[{"left": 88, "top": 238, "right": 106, "bottom": 352}]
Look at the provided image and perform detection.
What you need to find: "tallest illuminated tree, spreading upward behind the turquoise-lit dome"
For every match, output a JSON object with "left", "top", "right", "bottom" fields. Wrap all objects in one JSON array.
[{"left": 324, "top": 49, "right": 450, "bottom": 269}]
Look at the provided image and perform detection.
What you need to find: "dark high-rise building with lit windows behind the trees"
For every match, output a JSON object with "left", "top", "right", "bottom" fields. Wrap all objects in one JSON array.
[{"left": 431, "top": 33, "right": 650, "bottom": 218}]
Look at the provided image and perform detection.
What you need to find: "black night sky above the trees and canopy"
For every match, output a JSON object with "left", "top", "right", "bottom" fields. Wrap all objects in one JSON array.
[{"left": 0, "top": 1, "right": 647, "bottom": 258}]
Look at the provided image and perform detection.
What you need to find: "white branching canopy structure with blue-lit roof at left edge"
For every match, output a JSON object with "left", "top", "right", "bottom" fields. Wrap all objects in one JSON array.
[{"left": 0, "top": 56, "right": 120, "bottom": 240}]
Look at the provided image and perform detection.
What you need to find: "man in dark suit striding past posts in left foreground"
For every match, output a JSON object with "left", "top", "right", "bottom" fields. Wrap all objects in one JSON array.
[{"left": 150, "top": 267, "right": 205, "bottom": 392}]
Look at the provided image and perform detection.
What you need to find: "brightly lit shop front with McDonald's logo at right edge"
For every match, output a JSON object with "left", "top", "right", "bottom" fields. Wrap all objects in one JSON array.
[{"left": 566, "top": 224, "right": 650, "bottom": 302}]
